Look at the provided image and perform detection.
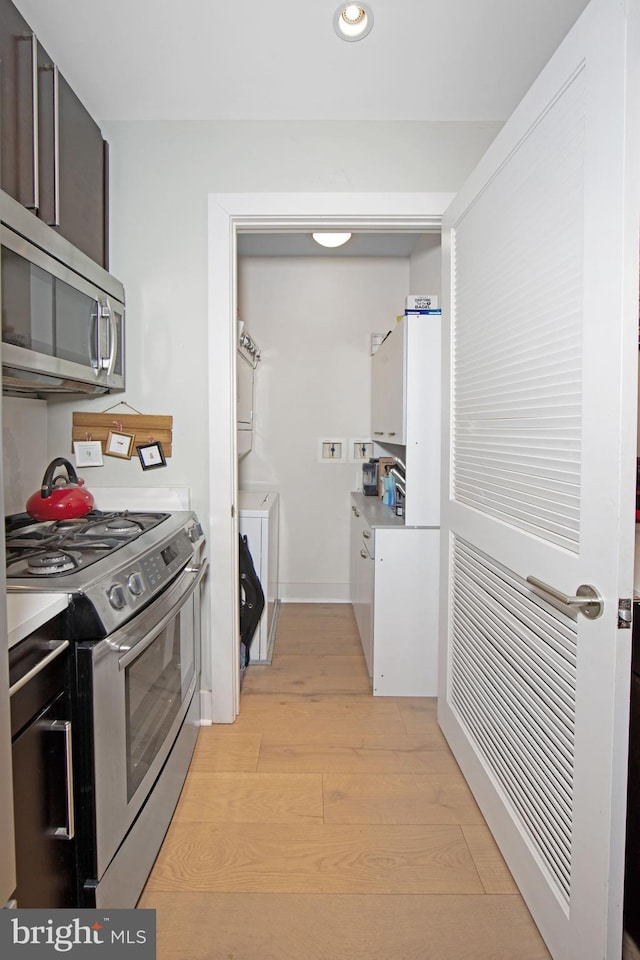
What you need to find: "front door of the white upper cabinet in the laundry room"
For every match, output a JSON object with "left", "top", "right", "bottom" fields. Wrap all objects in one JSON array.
[{"left": 371, "top": 320, "right": 406, "bottom": 444}]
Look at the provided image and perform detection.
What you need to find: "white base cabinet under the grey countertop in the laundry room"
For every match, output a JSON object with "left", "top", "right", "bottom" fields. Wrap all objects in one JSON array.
[{"left": 351, "top": 494, "right": 440, "bottom": 697}]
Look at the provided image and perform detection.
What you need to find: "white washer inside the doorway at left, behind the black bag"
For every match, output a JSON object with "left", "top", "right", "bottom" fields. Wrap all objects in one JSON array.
[{"left": 238, "top": 490, "right": 280, "bottom": 663}]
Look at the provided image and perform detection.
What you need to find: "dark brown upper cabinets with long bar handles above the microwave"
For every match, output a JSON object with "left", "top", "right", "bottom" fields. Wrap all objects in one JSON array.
[{"left": 0, "top": 0, "right": 109, "bottom": 269}]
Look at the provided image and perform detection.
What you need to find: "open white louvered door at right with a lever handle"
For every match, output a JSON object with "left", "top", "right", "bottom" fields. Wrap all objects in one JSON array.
[{"left": 438, "top": 0, "right": 640, "bottom": 960}]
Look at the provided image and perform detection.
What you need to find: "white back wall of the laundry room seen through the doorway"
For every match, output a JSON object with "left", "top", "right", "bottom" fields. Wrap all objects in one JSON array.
[{"left": 238, "top": 257, "right": 409, "bottom": 601}]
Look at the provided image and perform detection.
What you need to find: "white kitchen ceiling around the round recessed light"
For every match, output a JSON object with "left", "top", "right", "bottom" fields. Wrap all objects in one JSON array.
[{"left": 14, "top": 0, "right": 586, "bottom": 125}]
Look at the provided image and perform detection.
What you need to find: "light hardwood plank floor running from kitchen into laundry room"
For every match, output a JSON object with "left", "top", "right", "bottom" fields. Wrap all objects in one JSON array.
[{"left": 139, "top": 604, "right": 549, "bottom": 960}]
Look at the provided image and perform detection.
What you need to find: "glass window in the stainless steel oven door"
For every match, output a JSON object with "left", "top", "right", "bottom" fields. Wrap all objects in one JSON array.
[{"left": 125, "top": 603, "right": 196, "bottom": 801}]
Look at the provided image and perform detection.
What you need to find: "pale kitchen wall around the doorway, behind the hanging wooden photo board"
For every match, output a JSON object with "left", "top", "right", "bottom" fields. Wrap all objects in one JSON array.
[{"left": 41, "top": 121, "right": 501, "bottom": 696}]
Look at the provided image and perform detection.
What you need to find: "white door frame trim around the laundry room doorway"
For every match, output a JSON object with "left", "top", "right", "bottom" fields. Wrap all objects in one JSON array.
[{"left": 203, "top": 193, "right": 454, "bottom": 723}]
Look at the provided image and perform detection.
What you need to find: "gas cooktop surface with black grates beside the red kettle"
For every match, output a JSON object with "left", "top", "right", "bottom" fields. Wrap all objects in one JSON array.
[{"left": 5, "top": 510, "right": 169, "bottom": 580}]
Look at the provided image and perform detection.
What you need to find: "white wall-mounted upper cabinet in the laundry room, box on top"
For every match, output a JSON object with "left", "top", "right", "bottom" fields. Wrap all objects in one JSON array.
[{"left": 371, "top": 314, "right": 441, "bottom": 527}]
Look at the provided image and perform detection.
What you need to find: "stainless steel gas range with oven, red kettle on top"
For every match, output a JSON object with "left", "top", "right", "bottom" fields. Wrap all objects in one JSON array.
[{"left": 5, "top": 511, "right": 207, "bottom": 907}]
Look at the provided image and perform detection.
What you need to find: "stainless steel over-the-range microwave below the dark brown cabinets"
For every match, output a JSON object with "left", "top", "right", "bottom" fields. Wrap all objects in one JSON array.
[{"left": 0, "top": 192, "right": 125, "bottom": 396}]
